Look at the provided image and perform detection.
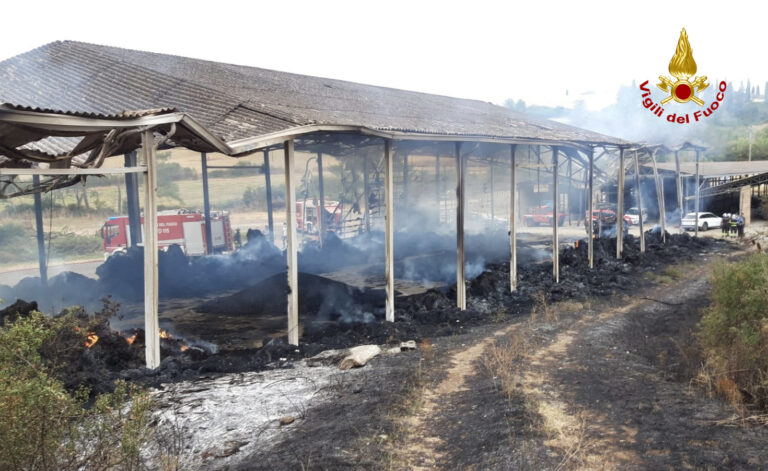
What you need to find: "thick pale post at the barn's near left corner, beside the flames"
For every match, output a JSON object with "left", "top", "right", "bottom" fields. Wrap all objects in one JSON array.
[{"left": 141, "top": 131, "right": 160, "bottom": 369}]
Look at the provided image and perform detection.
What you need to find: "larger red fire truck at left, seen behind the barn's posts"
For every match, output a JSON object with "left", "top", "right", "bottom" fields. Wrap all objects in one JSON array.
[{"left": 101, "top": 209, "right": 232, "bottom": 259}]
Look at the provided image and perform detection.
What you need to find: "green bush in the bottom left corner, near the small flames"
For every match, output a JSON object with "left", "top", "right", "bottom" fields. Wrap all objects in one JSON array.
[{"left": 0, "top": 312, "right": 151, "bottom": 470}]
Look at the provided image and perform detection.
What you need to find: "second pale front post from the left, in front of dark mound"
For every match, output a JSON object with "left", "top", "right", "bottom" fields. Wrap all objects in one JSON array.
[{"left": 283, "top": 139, "right": 299, "bottom": 345}]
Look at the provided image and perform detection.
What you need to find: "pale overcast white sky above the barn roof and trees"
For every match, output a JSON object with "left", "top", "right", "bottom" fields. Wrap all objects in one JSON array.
[{"left": 0, "top": 0, "right": 768, "bottom": 109}]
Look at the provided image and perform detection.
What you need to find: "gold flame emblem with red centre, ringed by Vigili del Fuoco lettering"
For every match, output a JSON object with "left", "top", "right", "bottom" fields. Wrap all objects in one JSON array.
[{"left": 656, "top": 28, "right": 709, "bottom": 106}]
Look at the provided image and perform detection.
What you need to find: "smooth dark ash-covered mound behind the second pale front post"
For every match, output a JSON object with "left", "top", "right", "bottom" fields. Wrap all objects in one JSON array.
[{"left": 198, "top": 273, "right": 385, "bottom": 322}]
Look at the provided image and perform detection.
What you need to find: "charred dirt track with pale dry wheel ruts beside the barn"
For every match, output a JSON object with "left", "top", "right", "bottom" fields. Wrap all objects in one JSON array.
[{"left": 392, "top": 251, "right": 768, "bottom": 470}]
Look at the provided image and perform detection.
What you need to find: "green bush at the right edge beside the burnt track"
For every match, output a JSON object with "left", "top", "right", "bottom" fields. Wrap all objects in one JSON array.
[{"left": 698, "top": 253, "right": 768, "bottom": 407}]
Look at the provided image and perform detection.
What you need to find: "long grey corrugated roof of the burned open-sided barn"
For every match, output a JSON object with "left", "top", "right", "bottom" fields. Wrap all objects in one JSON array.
[{"left": 0, "top": 41, "right": 628, "bottom": 154}]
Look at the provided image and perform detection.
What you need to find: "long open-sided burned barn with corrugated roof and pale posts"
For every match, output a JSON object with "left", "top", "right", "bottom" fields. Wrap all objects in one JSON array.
[{"left": 0, "top": 41, "right": 700, "bottom": 368}]
